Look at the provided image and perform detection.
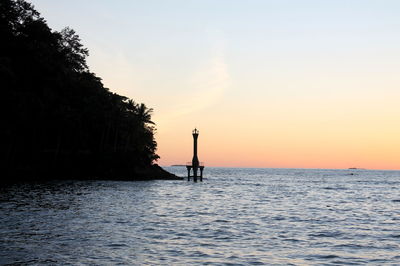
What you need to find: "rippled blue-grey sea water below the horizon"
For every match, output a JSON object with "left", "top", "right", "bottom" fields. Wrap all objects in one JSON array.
[{"left": 0, "top": 167, "right": 400, "bottom": 265}]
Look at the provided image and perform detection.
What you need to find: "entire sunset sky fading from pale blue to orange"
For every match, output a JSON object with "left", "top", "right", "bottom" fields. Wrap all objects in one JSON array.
[{"left": 31, "top": 0, "right": 400, "bottom": 169}]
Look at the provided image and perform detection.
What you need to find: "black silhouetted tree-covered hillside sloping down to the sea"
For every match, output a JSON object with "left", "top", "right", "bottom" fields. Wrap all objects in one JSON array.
[{"left": 0, "top": 0, "right": 180, "bottom": 182}]
